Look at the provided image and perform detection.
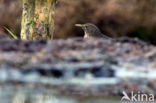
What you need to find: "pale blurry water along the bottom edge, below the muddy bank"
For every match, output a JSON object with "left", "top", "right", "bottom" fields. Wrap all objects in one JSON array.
[{"left": 0, "top": 85, "right": 120, "bottom": 103}]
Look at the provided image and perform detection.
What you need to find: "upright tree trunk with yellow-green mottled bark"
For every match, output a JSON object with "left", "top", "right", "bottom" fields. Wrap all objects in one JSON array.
[{"left": 21, "top": 0, "right": 56, "bottom": 40}]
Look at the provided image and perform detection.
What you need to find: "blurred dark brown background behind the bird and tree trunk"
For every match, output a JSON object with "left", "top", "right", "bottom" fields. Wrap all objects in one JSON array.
[{"left": 0, "top": 0, "right": 156, "bottom": 44}]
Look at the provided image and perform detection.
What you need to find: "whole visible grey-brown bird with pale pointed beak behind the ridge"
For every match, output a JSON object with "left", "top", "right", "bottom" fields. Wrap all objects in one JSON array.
[{"left": 75, "top": 23, "right": 112, "bottom": 39}]
